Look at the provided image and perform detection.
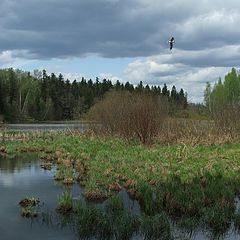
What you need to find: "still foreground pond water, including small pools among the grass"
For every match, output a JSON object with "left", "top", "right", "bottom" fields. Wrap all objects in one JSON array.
[{"left": 0, "top": 154, "right": 240, "bottom": 240}]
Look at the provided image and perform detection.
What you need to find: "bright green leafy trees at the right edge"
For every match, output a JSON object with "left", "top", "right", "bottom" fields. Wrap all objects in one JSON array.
[{"left": 204, "top": 68, "right": 240, "bottom": 131}]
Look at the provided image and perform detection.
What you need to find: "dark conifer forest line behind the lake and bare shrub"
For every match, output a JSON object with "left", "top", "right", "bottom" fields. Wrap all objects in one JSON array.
[{"left": 0, "top": 68, "right": 187, "bottom": 122}]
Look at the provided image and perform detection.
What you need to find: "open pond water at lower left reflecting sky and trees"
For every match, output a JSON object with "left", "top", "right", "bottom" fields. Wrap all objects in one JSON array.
[{"left": 0, "top": 155, "right": 79, "bottom": 240}]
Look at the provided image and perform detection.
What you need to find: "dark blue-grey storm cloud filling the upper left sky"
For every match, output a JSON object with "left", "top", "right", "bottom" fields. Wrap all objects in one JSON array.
[{"left": 0, "top": 0, "right": 166, "bottom": 58}]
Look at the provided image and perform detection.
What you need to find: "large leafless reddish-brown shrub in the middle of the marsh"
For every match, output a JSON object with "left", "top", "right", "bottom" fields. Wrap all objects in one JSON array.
[{"left": 90, "top": 91, "right": 168, "bottom": 144}]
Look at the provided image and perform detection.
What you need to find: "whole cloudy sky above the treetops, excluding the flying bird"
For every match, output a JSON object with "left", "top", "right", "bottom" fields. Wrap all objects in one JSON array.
[{"left": 0, "top": 0, "right": 240, "bottom": 102}]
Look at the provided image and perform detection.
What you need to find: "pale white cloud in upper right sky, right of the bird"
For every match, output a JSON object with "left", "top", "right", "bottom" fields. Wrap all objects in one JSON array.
[{"left": 176, "top": 9, "right": 240, "bottom": 49}]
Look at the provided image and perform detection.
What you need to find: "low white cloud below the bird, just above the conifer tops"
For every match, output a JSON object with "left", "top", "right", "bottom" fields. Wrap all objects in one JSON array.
[{"left": 124, "top": 56, "right": 230, "bottom": 102}]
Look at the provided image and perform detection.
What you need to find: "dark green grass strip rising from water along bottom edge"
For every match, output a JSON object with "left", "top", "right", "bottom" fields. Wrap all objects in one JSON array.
[{"left": 44, "top": 195, "right": 240, "bottom": 240}]
